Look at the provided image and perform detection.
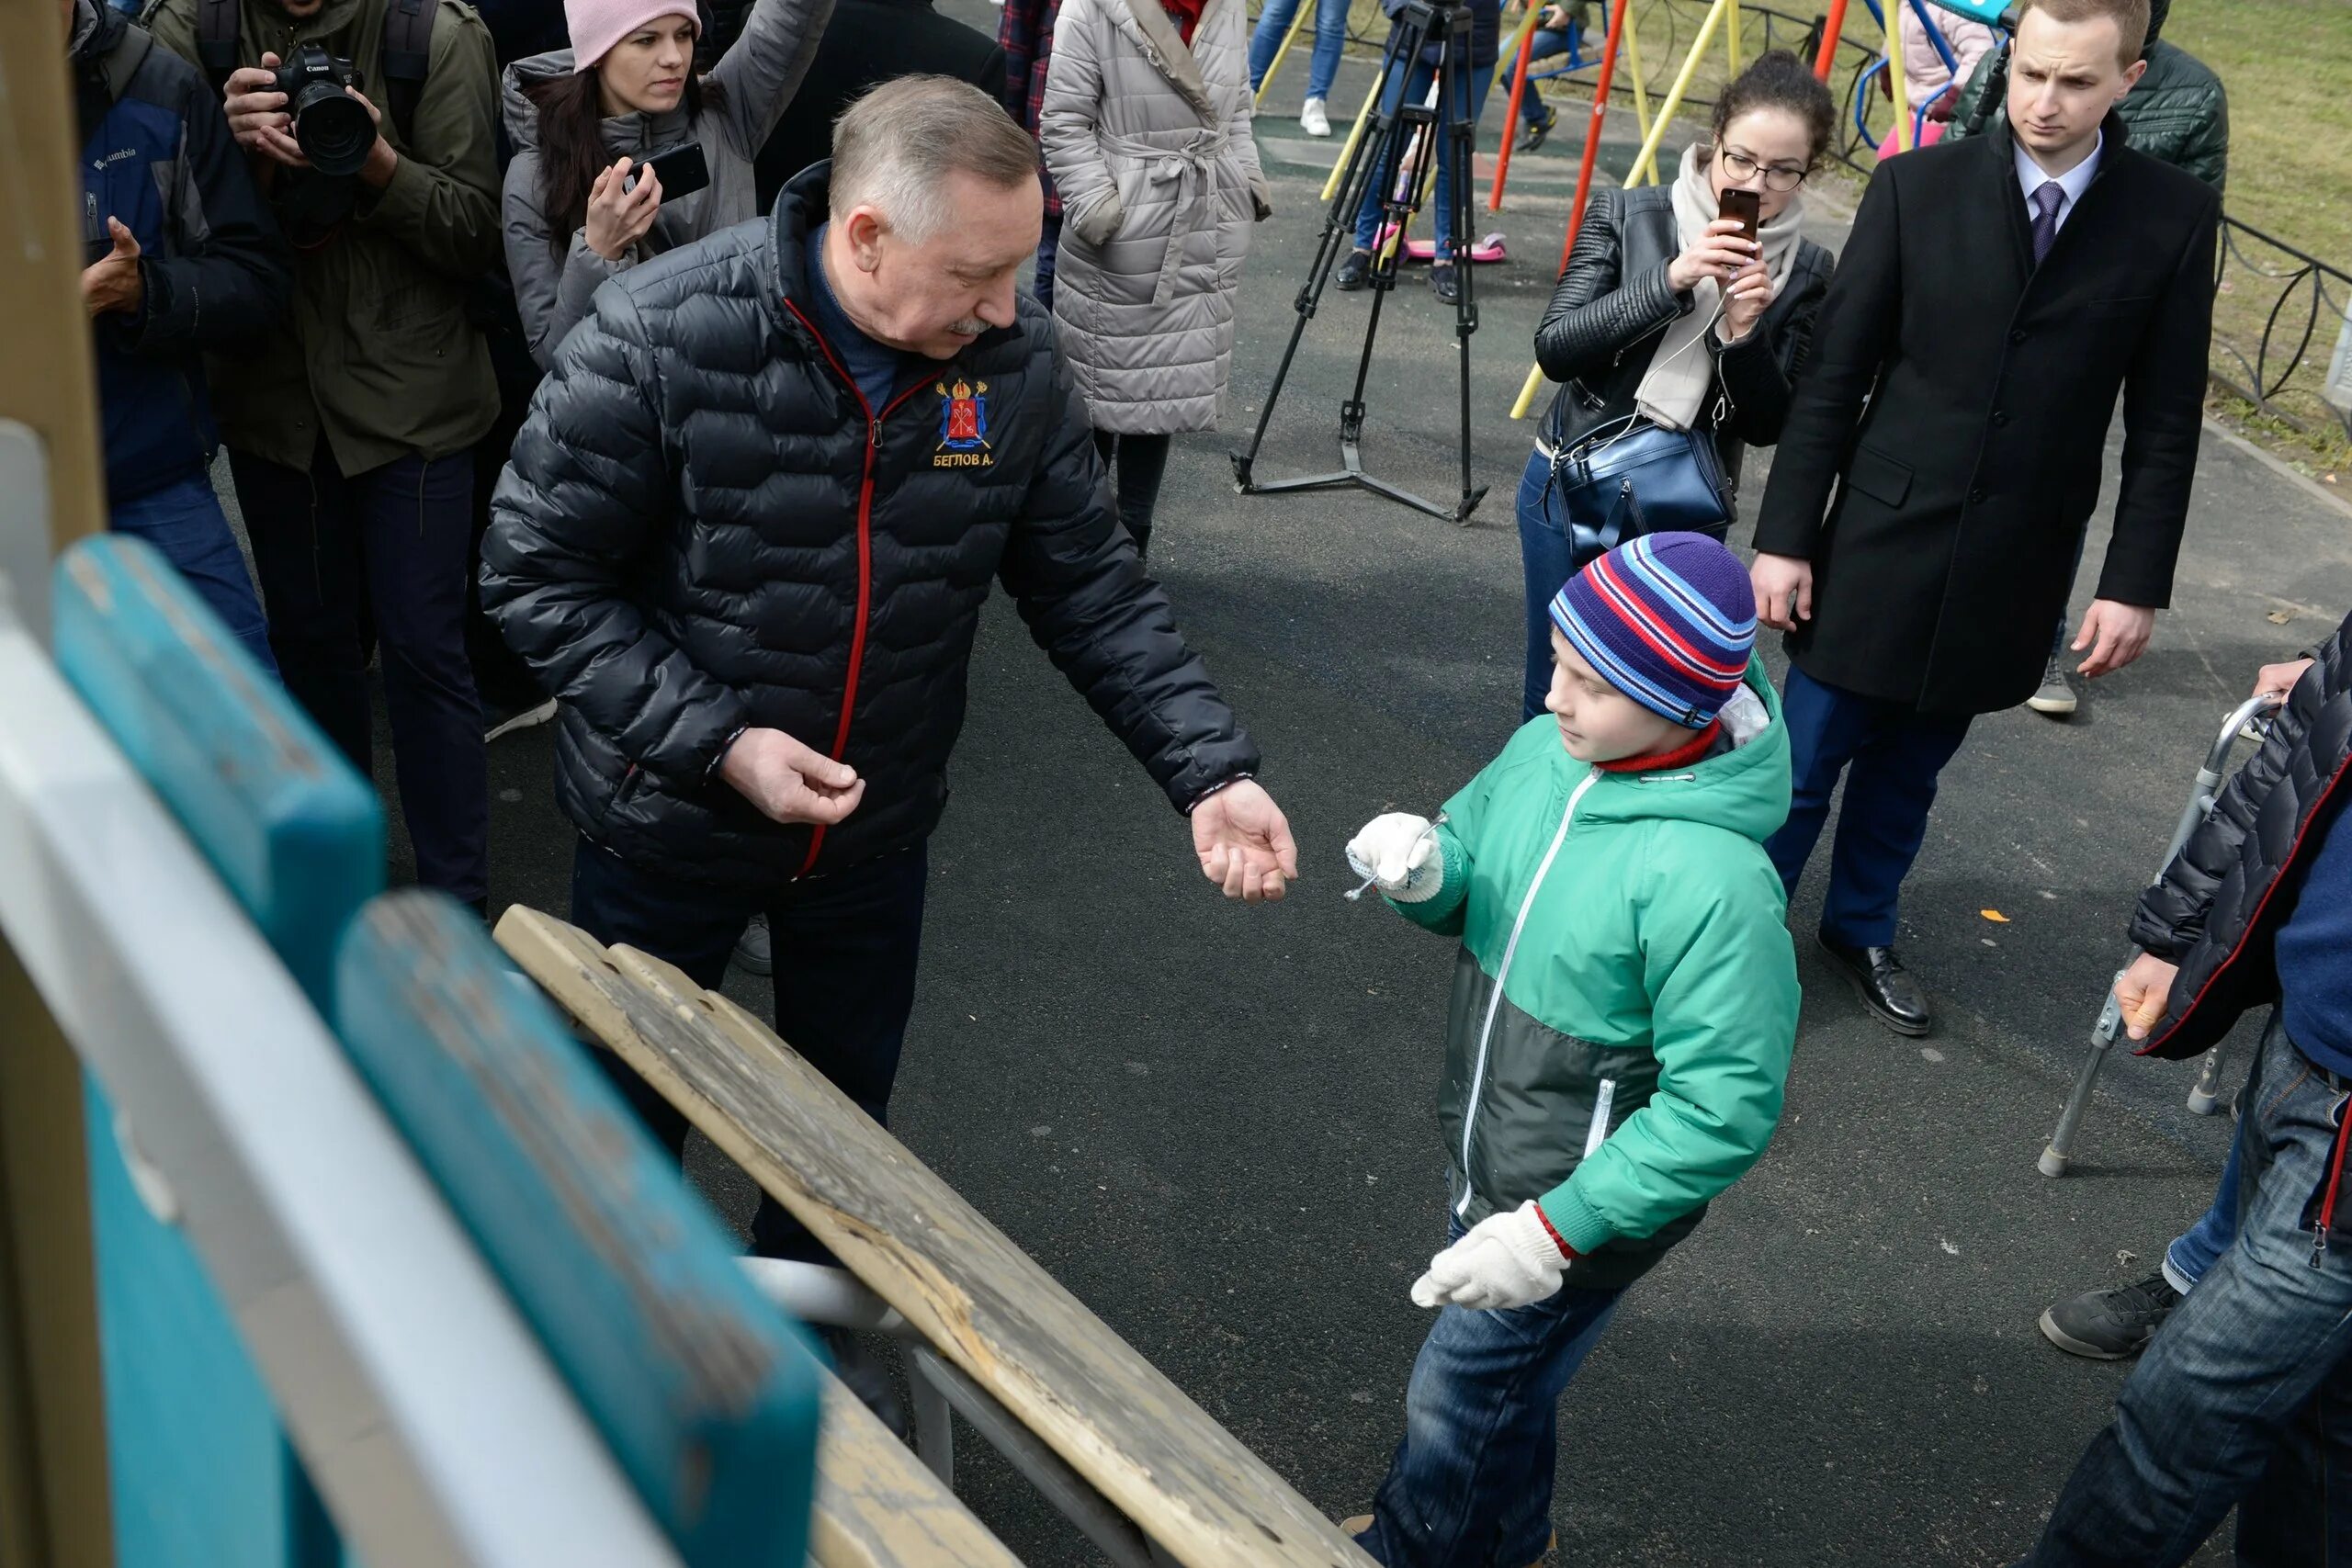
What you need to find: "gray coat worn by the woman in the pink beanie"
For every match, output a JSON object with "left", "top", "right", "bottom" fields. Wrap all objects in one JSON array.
[{"left": 501, "top": 0, "right": 832, "bottom": 369}]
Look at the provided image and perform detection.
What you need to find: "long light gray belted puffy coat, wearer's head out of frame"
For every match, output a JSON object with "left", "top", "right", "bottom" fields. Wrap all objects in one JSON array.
[{"left": 1037, "top": 0, "right": 1272, "bottom": 434}]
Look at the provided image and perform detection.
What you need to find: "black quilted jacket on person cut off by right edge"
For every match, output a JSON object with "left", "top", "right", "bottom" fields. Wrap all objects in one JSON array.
[{"left": 2131, "top": 621, "right": 2352, "bottom": 1058}]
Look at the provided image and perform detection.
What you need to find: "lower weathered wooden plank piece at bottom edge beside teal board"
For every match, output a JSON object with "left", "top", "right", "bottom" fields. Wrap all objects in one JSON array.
[{"left": 809, "top": 1373, "right": 1021, "bottom": 1568}]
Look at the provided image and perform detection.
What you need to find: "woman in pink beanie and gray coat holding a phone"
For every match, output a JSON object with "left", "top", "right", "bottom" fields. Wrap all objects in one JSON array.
[{"left": 503, "top": 0, "right": 832, "bottom": 369}]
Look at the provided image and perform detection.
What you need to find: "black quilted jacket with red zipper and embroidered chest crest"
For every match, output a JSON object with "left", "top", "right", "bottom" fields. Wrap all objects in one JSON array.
[{"left": 482, "top": 164, "right": 1259, "bottom": 886}]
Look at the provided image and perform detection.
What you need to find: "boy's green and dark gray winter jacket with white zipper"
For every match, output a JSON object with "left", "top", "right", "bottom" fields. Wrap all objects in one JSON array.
[{"left": 1393, "top": 663, "right": 1797, "bottom": 1286}]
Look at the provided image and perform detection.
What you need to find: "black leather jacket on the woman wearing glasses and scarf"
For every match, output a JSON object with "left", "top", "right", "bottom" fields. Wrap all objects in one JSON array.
[{"left": 1536, "top": 186, "right": 1837, "bottom": 522}]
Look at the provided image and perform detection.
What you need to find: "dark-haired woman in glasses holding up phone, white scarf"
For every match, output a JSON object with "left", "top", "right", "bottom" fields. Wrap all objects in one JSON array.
[{"left": 1520, "top": 50, "right": 1837, "bottom": 719}]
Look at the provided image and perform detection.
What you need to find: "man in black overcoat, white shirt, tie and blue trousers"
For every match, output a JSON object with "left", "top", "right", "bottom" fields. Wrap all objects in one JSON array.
[{"left": 1755, "top": 0, "right": 2221, "bottom": 1034}]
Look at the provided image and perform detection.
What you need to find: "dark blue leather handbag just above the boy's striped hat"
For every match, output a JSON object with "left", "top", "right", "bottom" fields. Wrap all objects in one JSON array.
[{"left": 1550, "top": 413, "right": 1731, "bottom": 571}]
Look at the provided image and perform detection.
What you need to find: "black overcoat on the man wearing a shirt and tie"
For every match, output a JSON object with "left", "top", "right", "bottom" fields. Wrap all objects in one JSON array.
[{"left": 1755, "top": 115, "right": 2221, "bottom": 712}]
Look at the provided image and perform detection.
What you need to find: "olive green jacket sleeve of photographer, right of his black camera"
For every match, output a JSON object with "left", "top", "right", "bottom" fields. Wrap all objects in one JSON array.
[{"left": 353, "top": 5, "right": 501, "bottom": 282}]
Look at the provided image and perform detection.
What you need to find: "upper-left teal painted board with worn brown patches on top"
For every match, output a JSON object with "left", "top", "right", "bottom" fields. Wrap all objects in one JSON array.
[{"left": 54, "top": 536, "right": 383, "bottom": 1013}]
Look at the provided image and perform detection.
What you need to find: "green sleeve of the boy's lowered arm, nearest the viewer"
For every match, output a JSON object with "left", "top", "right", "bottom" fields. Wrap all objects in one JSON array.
[{"left": 1538, "top": 832, "right": 1797, "bottom": 1253}]
